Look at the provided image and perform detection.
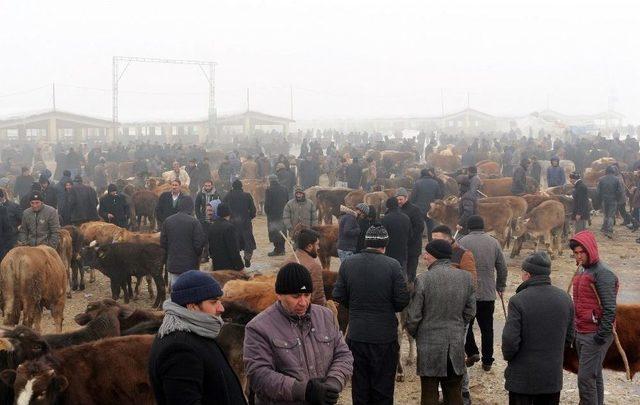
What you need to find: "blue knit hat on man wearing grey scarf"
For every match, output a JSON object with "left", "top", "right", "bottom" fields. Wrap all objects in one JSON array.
[{"left": 171, "top": 270, "right": 223, "bottom": 307}]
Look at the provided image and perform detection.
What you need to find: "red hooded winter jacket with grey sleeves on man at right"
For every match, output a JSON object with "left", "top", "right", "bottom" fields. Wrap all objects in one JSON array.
[{"left": 571, "top": 231, "right": 619, "bottom": 341}]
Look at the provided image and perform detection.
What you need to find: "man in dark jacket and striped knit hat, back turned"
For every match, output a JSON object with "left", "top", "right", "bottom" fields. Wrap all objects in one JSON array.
[{"left": 333, "top": 224, "right": 409, "bottom": 405}]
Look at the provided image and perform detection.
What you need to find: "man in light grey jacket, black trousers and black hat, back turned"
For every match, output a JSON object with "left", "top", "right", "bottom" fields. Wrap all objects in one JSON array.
[{"left": 459, "top": 215, "right": 507, "bottom": 371}]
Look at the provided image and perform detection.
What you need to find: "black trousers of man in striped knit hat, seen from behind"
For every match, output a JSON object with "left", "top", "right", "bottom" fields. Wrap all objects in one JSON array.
[{"left": 347, "top": 339, "right": 400, "bottom": 405}]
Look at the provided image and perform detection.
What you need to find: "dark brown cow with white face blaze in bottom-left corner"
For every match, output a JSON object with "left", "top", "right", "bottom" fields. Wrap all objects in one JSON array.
[{"left": 0, "top": 335, "right": 155, "bottom": 405}]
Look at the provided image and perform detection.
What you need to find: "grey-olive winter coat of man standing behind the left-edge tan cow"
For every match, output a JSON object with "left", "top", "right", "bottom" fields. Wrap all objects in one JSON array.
[{"left": 18, "top": 204, "right": 60, "bottom": 249}]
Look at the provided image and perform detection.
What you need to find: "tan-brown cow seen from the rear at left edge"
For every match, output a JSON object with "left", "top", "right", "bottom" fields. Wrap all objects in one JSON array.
[{"left": 0, "top": 245, "right": 69, "bottom": 333}]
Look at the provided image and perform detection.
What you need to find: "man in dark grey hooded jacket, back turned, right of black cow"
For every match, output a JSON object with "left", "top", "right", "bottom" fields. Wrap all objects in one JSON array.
[{"left": 160, "top": 196, "right": 206, "bottom": 285}]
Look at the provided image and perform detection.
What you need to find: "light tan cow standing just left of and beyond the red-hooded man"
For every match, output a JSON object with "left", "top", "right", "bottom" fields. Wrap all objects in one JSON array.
[{"left": 511, "top": 200, "right": 565, "bottom": 259}]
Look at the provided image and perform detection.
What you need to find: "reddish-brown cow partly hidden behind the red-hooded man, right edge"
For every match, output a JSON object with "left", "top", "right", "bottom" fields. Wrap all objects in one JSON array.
[{"left": 564, "top": 304, "right": 640, "bottom": 379}]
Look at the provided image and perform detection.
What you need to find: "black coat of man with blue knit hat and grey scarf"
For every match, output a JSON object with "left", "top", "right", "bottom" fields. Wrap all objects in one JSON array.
[{"left": 148, "top": 331, "right": 247, "bottom": 405}]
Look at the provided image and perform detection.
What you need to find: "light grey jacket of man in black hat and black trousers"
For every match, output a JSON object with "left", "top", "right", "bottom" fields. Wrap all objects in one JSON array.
[{"left": 458, "top": 231, "right": 507, "bottom": 301}]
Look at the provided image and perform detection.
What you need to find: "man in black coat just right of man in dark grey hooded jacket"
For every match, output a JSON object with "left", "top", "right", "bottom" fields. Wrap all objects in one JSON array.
[{"left": 207, "top": 203, "right": 244, "bottom": 270}]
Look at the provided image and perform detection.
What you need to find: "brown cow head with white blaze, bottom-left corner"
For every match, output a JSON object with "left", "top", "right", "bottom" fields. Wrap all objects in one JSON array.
[{"left": 0, "top": 359, "right": 69, "bottom": 405}]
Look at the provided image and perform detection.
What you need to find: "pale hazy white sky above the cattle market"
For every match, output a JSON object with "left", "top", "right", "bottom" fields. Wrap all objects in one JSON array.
[{"left": 0, "top": 0, "right": 640, "bottom": 122}]
